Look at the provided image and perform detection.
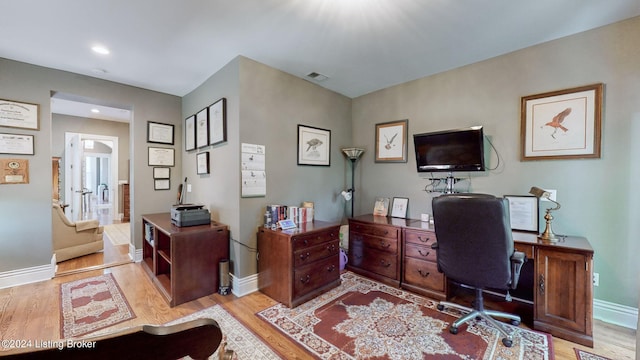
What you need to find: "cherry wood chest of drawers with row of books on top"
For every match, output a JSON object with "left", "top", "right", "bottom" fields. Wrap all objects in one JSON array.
[{"left": 258, "top": 221, "right": 340, "bottom": 307}]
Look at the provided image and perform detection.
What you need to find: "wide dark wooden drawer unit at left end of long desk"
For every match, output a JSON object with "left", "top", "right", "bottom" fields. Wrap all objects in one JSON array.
[{"left": 347, "top": 218, "right": 402, "bottom": 287}]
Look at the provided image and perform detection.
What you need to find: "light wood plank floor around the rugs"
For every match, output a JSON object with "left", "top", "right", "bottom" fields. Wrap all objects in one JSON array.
[{"left": 0, "top": 263, "right": 635, "bottom": 360}]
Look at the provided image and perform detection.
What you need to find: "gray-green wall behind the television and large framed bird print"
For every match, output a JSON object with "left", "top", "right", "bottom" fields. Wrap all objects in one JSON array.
[{"left": 353, "top": 18, "right": 640, "bottom": 307}]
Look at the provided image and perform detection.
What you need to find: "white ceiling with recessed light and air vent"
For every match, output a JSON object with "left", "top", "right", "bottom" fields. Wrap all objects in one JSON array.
[{"left": 0, "top": 0, "right": 640, "bottom": 120}]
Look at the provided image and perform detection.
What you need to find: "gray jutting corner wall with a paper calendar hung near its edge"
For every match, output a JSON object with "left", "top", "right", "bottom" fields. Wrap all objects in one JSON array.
[{"left": 183, "top": 57, "right": 351, "bottom": 277}]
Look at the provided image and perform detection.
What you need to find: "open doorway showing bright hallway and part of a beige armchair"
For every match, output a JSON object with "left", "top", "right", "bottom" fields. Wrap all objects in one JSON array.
[{"left": 51, "top": 93, "right": 135, "bottom": 276}]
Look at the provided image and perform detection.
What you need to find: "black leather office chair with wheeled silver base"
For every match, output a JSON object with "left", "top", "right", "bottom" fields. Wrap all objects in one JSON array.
[{"left": 432, "top": 194, "right": 526, "bottom": 347}]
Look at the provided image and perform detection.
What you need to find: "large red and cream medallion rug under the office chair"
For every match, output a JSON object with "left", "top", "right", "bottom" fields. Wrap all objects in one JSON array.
[{"left": 257, "top": 272, "right": 554, "bottom": 360}]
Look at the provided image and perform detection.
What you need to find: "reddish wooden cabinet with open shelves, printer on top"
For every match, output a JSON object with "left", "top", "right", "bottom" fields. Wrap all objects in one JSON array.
[{"left": 142, "top": 213, "right": 229, "bottom": 307}]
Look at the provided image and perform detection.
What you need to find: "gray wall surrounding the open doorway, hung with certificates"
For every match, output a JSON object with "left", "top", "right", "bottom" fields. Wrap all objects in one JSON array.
[{"left": 0, "top": 58, "right": 182, "bottom": 272}]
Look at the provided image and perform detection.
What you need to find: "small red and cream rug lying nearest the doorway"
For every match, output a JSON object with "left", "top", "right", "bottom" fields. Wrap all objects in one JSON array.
[{"left": 60, "top": 273, "right": 136, "bottom": 339}]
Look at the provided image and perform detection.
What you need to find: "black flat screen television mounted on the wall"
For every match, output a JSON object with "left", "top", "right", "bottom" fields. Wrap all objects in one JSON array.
[{"left": 413, "top": 126, "right": 484, "bottom": 172}]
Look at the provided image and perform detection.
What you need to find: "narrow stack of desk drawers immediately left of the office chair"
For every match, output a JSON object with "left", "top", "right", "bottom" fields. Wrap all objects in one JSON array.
[{"left": 402, "top": 228, "right": 447, "bottom": 300}]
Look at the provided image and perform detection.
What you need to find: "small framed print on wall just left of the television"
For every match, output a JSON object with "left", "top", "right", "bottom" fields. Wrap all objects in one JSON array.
[{"left": 375, "top": 120, "right": 409, "bottom": 162}]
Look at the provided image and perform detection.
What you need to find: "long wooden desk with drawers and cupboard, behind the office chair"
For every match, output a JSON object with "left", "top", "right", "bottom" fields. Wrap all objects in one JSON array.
[{"left": 348, "top": 215, "right": 593, "bottom": 347}]
